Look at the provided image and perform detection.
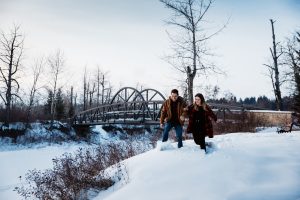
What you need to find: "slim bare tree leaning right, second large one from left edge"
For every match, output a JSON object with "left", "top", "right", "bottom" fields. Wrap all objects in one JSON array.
[{"left": 26, "top": 58, "right": 45, "bottom": 126}]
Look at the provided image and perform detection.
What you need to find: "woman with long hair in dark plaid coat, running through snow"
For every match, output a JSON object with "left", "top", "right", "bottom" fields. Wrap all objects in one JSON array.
[{"left": 187, "top": 93, "right": 217, "bottom": 152}]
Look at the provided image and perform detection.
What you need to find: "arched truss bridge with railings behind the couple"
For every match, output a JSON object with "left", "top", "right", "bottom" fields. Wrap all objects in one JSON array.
[{"left": 72, "top": 87, "right": 262, "bottom": 126}]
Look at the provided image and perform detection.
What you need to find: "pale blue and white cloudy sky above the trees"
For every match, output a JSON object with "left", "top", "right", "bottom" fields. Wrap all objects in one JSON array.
[{"left": 0, "top": 0, "right": 300, "bottom": 98}]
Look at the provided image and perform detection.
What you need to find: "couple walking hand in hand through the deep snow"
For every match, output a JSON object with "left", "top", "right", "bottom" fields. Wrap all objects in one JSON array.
[{"left": 160, "top": 89, "right": 217, "bottom": 152}]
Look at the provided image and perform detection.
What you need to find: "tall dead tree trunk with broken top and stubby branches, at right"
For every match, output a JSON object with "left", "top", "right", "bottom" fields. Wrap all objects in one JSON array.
[{"left": 264, "top": 19, "right": 283, "bottom": 110}]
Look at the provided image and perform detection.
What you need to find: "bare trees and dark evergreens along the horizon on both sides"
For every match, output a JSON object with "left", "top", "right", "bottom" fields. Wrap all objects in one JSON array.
[{"left": 0, "top": 26, "right": 300, "bottom": 126}]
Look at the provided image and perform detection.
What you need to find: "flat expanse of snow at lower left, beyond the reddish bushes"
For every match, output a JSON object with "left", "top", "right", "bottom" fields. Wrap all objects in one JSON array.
[{"left": 0, "top": 143, "right": 88, "bottom": 200}]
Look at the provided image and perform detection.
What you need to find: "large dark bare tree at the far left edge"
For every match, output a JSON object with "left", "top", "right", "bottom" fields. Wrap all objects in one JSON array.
[{"left": 0, "top": 25, "right": 24, "bottom": 126}]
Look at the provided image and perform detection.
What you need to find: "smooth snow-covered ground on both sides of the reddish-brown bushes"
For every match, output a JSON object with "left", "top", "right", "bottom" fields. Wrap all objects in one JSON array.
[{"left": 0, "top": 130, "right": 300, "bottom": 200}]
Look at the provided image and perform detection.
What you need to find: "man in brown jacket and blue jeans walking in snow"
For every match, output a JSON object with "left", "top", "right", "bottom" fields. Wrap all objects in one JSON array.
[{"left": 160, "top": 89, "right": 187, "bottom": 148}]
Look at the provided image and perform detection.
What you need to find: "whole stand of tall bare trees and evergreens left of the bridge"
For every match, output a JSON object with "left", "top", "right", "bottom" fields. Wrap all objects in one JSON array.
[{"left": 0, "top": 25, "right": 112, "bottom": 126}]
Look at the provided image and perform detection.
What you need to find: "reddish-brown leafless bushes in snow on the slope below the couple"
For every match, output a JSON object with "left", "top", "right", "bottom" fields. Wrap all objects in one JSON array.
[{"left": 15, "top": 142, "right": 148, "bottom": 200}]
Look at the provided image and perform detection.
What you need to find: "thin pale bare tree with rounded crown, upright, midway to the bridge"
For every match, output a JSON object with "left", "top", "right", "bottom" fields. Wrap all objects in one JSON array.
[{"left": 48, "top": 50, "right": 65, "bottom": 124}]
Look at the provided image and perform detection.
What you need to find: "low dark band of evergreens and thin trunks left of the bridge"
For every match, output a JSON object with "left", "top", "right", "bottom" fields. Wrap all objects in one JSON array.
[{"left": 0, "top": 83, "right": 111, "bottom": 123}]
